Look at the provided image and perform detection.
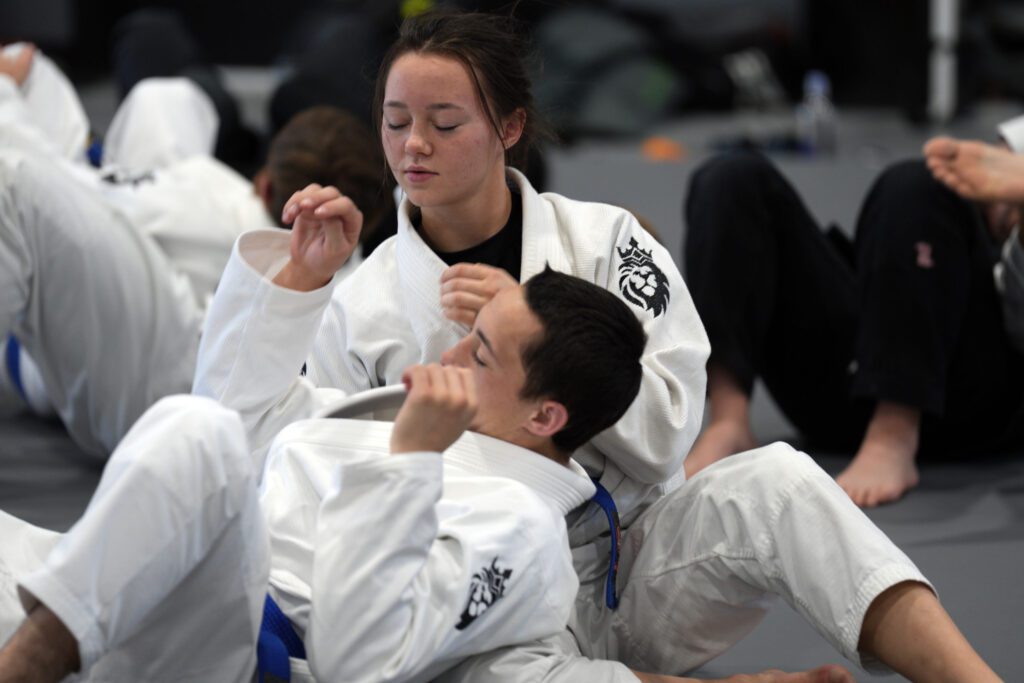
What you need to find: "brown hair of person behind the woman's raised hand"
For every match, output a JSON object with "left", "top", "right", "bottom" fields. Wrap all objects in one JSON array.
[{"left": 266, "top": 106, "right": 394, "bottom": 242}]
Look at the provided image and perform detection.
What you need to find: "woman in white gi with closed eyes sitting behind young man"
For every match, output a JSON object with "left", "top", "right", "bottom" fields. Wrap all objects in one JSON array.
[{"left": 196, "top": 6, "right": 984, "bottom": 681}]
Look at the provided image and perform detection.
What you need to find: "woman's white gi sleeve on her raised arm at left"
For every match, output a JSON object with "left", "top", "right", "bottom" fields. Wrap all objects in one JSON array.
[{"left": 193, "top": 229, "right": 344, "bottom": 463}]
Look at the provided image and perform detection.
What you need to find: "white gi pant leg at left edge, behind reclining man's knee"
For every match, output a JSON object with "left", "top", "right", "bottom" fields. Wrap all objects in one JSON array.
[{"left": 0, "top": 148, "right": 202, "bottom": 458}]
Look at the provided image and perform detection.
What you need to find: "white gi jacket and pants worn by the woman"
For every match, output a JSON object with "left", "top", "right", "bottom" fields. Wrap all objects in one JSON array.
[{"left": 196, "top": 171, "right": 927, "bottom": 681}]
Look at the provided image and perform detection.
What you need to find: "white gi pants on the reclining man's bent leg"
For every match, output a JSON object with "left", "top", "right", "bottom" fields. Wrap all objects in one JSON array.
[{"left": 0, "top": 396, "right": 269, "bottom": 683}]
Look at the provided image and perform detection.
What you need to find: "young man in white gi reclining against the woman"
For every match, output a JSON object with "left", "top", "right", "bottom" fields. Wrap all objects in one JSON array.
[{"left": 0, "top": 271, "right": 645, "bottom": 682}]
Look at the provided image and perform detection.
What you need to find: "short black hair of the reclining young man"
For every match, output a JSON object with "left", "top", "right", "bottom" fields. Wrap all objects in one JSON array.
[{"left": 520, "top": 268, "right": 647, "bottom": 454}]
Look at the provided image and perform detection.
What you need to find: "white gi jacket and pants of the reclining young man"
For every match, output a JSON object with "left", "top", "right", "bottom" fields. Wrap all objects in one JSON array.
[{"left": 0, "top": 396, "right": 594, "bottom": 683}]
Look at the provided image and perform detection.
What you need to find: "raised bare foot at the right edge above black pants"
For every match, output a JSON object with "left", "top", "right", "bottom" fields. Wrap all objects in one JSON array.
[{"left": 925, "top": 137, "right": 1024, "bottom": 204}]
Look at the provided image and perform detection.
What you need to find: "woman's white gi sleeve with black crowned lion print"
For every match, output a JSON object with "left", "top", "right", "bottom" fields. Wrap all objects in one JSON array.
[{"left": 592, "top": 212, "right": 711, "bottom": 484}]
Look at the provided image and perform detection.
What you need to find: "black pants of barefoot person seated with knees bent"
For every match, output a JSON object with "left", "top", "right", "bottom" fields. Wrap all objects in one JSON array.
[{"left": 685, "top": 153, "right": 1024, "bottom": 454}]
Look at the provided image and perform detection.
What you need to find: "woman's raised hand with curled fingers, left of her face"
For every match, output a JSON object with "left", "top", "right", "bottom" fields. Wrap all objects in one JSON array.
[{"left": 273, "top": 183, "right": 362, "bottom": 292}]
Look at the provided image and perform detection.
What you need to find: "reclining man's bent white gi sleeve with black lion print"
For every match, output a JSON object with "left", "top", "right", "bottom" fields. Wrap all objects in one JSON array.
[{"left": 305, "top": 453, "right": 579, "bottom": 683}]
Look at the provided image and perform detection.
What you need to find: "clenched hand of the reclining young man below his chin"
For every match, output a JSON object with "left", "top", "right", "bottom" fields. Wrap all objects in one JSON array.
[{"left": 391, "top": 364, "right": 476, "bottom": 454}]
